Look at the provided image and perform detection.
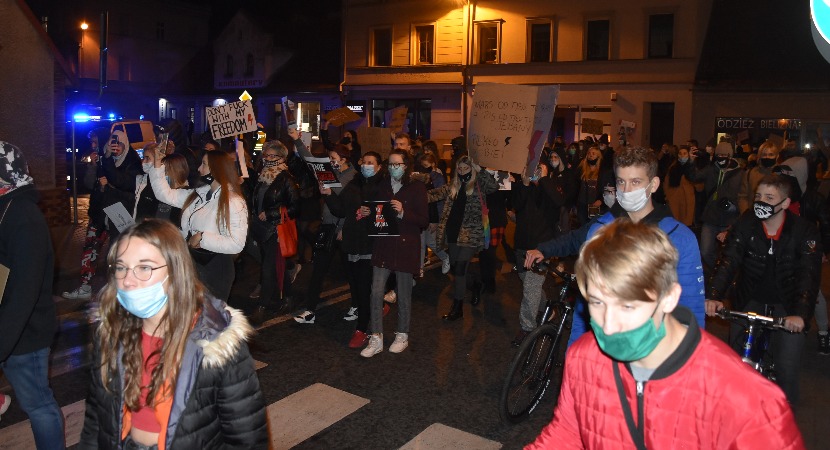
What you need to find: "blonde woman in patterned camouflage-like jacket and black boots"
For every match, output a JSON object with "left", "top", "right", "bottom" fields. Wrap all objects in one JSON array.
[{"left": 429, "top": 156, "right": 499, "bottom": 321}]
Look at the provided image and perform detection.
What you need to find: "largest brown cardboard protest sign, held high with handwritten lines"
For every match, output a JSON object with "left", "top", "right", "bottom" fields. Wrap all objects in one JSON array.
[{"left": 468, "top": 83, "right": 559, "bottom": 173}]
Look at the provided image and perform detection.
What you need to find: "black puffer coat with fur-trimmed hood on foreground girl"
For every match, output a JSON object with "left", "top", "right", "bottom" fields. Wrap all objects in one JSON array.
[{"left": 78, "top": 297, "right": 268, "bottom": 450}]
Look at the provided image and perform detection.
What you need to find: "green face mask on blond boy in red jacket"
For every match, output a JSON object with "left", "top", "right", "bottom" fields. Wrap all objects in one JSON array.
[{"left": 591, "top": 308, "right": 666, "bottom": 362}]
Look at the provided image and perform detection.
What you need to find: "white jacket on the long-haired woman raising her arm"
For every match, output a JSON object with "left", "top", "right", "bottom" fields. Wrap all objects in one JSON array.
[{"left": 150, "top": 166, "right": 248, "bottom": 255}]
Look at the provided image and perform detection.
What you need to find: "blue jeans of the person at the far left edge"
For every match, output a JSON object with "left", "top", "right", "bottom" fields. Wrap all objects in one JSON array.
[{"left": 0, "top": 347, "right": 66, "bottom": 450}]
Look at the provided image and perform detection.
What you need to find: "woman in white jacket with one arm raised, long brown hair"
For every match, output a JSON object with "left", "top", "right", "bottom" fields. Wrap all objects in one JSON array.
[{"left": 150, "top": 152, "right": 248, "bottom": 300}]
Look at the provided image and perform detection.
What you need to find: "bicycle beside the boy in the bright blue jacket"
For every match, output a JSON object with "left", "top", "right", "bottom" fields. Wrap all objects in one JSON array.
[{"left": 499, "top": 262, "right": 576, "bottom": 424}]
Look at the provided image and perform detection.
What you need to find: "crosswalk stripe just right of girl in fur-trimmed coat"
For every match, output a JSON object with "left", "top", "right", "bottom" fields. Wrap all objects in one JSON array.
[{"left": 268, "top": 383, "right": 369, "bottom": 450}]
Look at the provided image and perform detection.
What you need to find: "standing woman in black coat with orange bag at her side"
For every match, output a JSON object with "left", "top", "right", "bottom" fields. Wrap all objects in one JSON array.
[{"left": 250, "top": 140, "right": 299, "bottom": 313}]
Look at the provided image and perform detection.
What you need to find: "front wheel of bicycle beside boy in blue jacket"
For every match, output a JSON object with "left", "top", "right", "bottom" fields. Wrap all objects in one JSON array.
[{"left": 499, "top": 322, "right": 564, "bottom": 423}]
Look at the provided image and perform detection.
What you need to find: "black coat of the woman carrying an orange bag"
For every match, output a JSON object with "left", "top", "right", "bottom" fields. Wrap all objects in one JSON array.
[{"left": 249, "top": 170, "right": 300, "bottom": 244}]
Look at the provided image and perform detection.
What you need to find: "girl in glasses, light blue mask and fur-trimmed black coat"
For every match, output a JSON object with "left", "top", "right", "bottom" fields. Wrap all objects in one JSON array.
[{"left": 79, "top": 219, "right": 268, "bottom": 450}]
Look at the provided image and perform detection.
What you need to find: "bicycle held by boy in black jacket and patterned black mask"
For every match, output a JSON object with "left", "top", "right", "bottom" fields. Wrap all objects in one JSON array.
[{"left": 717, "top": 308, "right": 790, "bottom": 382}]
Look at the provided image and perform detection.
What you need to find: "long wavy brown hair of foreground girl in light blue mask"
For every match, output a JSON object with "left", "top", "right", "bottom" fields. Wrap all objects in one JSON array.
[{"left": 96, "top": 219, "right": 205, "bottom": 411}]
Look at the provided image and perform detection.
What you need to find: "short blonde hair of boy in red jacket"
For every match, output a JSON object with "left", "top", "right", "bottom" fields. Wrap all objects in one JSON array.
[{"left": 576, "top": 219, "right": 679, "bottom": 302}]
